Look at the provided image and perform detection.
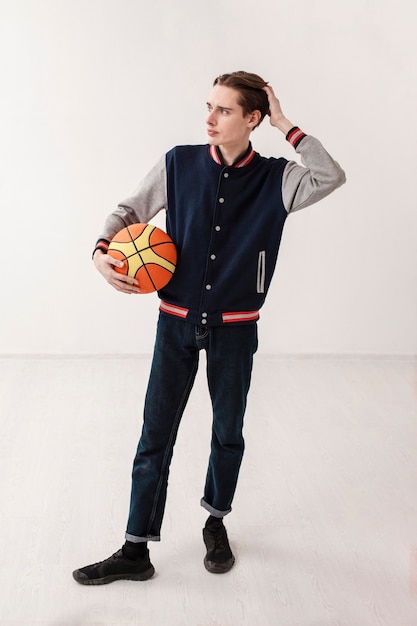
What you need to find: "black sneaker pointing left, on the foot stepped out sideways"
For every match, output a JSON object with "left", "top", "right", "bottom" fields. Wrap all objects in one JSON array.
[{"left": 72, "top": 549, "right": 155, "bottom": 585}]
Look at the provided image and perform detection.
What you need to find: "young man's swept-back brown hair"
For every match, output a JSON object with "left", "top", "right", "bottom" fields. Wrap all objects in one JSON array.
[{"left": 213, "top": 71, "right": 269, "bottom": 128}]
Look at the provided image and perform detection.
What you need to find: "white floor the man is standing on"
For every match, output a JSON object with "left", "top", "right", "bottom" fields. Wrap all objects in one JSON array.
[{"left": 0, "top": 355, "right": 417, "bottom": 626}]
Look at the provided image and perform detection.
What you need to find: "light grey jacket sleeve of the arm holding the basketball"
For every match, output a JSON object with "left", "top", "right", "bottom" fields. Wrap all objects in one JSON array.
[{"left": 100, "top": 156, "right": 167, "bottom": 240}]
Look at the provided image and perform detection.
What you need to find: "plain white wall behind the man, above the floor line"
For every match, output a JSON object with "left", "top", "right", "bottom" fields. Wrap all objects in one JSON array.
[{"left": 0, "top": 0, "right": 417, "bottom": 354}]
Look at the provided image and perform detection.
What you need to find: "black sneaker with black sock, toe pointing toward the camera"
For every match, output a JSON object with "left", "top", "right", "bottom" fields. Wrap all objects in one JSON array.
[{"left": 203, "top": 517, "right": 235, "bottom": 574}]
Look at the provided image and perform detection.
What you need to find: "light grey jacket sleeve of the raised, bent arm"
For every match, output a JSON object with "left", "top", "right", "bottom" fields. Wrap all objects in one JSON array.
[{"left": 282, "top": 135, "right": 346, "bottom": 213}]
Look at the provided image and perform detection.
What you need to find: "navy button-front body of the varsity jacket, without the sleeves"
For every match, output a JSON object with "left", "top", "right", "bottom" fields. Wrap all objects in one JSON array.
[{"left": 159, "top": 146, "right": 287, "bottom": 326}]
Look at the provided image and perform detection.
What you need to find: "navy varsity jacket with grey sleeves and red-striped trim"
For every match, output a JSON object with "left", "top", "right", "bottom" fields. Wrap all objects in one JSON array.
[{"left": 96, "top": 127, "right": 345, "bottom": 326}]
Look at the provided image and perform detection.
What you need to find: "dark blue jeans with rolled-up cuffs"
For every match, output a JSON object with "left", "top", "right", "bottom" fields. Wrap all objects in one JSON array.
[{"left": 126, "top": 314, "right": 258, "bottom": 542}]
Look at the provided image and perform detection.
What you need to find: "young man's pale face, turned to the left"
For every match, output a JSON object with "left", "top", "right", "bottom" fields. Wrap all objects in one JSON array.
[{"left": 206, "top": 85, "right": 254, "bottom": 151}]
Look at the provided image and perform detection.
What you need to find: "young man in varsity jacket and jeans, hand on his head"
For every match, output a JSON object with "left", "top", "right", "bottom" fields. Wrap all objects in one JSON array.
[{"left": 73, "top": 72, "right": 345, "bottom": 585}]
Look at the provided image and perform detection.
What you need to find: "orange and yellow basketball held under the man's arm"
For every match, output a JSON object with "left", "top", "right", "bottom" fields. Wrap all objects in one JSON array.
[{"left": 108, "top": 224, "right": 177, "bottom": 293}]
